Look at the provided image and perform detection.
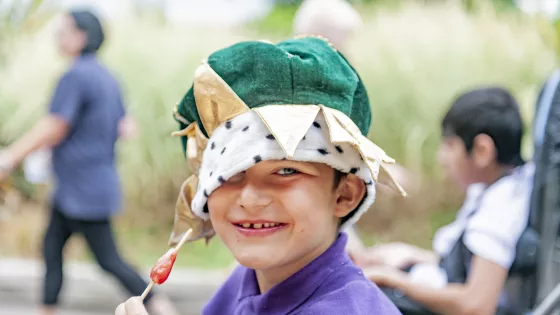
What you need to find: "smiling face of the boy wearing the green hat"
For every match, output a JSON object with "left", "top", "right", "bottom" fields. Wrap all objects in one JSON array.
[{"left": 208, "top": 160, "right": 365, "bottom": 272}]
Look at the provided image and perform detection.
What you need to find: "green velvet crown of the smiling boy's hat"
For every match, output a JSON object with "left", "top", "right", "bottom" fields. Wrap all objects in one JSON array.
[{"left": 177, "top": 37, "right": 371, "bottom": 149}]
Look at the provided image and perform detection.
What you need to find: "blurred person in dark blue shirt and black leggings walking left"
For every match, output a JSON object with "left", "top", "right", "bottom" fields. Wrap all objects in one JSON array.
[{"left": 0, "top": 10, "right": 175, "bottom": 315}]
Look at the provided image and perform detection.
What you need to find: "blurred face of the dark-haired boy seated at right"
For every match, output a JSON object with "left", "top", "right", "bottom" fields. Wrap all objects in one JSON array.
[{"left": 437, "top": 136, "right": 477, "bottom": 189}]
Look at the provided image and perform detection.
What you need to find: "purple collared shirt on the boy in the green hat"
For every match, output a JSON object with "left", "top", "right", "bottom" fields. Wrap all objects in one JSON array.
[{"left": 202, "top": 233, "right": 401, "bottom": 315}]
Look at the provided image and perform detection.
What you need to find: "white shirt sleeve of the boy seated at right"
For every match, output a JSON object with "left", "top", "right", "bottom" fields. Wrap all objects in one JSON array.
[{"left": 464, "top": 170, "right": 532, "bottom": 269}]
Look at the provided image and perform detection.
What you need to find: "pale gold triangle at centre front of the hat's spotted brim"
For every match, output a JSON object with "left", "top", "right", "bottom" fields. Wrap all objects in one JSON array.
[{"left": 253, "top": 105, "right": 321, "bottom": 159}]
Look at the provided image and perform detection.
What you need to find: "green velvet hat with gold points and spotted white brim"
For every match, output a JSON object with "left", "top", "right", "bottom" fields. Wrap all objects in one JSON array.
[{"left": 171, "top": 37, "right": 400, "bottom": 243}]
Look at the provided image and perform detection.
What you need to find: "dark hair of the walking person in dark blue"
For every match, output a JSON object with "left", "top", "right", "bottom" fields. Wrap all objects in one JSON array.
[{"left": 69, "top": 10, "right": 105, "bottom": 55}]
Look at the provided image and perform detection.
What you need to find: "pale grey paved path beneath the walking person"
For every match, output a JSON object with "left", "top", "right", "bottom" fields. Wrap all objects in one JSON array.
[{"left": 0, "top": 259, "right": 224, "bottom": 315}]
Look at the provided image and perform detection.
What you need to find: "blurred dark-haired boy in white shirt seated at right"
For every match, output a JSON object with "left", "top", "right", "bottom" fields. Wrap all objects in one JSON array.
[{"left": 354, "top": 87, "right": 534, "bottom": 315}]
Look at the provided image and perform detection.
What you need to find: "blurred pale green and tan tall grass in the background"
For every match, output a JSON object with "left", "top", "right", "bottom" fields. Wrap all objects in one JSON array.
[{"left": 0, "top": 0, "right": 560, "bottom": 314}]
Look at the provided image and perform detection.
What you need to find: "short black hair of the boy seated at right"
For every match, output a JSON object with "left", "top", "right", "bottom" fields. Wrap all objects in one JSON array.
[{"left": 442, "top": 87, "right": 523, "bottom": 165}]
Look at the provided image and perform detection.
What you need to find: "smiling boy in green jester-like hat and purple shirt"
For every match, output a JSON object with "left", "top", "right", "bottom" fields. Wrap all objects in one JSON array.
[{"left": 116, "top": 38, "right": 400, "bottom": 315}]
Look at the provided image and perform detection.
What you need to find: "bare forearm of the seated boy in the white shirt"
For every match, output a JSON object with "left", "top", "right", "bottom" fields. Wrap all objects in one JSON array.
[{"left": 369, "top": 256, "right": 508, "bottom": 315}]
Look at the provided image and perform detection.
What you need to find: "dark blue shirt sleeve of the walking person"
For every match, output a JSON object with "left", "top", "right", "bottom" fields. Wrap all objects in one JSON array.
[{"left": 49, "top": 71, "right": 83, "bottom": 125}]
